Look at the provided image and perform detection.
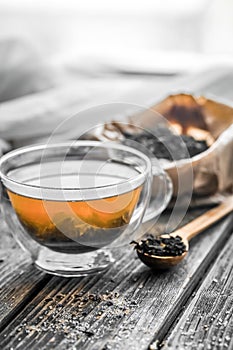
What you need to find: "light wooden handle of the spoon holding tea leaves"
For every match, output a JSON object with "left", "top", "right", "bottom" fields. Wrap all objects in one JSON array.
[{"left": 172, "top": 196, "right": 233, "bottom": 241}]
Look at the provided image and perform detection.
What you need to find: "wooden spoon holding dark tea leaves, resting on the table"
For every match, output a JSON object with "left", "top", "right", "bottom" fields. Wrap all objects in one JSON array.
[{"left": 137, "top": 196, "right": 233, "bottom": 270}]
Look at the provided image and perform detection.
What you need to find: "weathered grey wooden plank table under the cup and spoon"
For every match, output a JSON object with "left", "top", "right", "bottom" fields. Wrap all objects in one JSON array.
[{"left": 0, "top": 67, "right": 233, "bottom": 350}]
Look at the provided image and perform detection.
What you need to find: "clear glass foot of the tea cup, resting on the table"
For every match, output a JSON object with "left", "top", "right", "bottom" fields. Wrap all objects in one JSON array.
[{"left": 34, "top": 248, "right": 114, "bottom": 277}]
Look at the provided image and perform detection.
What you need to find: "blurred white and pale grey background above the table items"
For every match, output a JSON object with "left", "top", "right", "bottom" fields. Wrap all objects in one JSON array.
[{"left": 0, "top": 0, "right": 233, "bottom": 146}]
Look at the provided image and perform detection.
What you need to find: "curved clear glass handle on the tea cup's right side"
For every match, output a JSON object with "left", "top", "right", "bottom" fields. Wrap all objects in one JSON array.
[{"left": 142, "top": 164, "right": 173, "bottom": 223}]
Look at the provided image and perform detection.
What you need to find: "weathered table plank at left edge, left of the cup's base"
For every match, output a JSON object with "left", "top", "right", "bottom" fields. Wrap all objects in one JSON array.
[{"left": 0, "top": 222, "right": 51, "bottom": 330}]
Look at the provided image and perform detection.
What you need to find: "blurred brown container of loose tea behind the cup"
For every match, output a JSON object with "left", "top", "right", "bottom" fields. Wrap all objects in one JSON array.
[{"left": 89, "top": 94, "right": 233, "bottom": 197}]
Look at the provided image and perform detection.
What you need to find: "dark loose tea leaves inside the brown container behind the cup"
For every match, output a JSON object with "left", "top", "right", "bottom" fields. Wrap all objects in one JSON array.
[{"left": 123, "top": 127, "right": 208, "bottom": 160}]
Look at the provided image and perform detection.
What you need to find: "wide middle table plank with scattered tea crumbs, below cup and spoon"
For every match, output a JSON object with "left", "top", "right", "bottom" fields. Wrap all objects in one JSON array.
[{"left": 0, "top": 211, "right": 232, "bottom": 350}]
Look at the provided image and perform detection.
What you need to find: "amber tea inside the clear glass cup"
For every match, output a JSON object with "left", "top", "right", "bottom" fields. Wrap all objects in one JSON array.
[{"left": 7, "top": 160, "right": 142, "bottom": 253}]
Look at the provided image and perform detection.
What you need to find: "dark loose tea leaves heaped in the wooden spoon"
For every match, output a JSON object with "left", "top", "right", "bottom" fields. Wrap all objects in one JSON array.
[{"left": 131, "top": 235, "right": 186, "bottom": 256}]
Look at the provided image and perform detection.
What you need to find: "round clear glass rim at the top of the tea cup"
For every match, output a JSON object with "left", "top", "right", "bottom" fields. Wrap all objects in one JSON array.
[{"left": 0, "top": 140, "right": 152, "bottom": 198}]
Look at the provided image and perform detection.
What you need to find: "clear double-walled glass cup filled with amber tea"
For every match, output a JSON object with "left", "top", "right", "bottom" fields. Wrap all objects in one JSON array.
[{"left": 0, "top": 141, "right": 171, "bottom": 277}]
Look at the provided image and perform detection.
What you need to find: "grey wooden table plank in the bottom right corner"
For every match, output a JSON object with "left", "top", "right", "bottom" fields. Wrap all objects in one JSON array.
[{"left": 163, "top": 230, "right": 233, "bottom": 350}]
